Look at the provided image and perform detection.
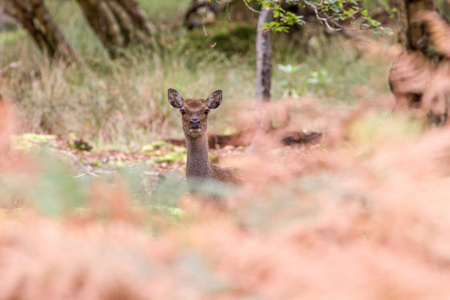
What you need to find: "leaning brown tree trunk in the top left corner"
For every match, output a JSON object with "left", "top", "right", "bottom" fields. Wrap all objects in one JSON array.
[{"left": 0, "top": 0, "right": 75, "bottom": 62}]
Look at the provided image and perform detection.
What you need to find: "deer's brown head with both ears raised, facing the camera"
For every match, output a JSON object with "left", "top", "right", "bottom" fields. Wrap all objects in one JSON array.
[{"left": 168, "top": 89, "right": 222, "bottom": 138}]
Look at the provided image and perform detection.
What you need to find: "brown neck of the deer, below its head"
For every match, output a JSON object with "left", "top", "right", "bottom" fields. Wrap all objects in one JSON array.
[{"left": 186, "top": 134, "right": 211, "bottom": 178}]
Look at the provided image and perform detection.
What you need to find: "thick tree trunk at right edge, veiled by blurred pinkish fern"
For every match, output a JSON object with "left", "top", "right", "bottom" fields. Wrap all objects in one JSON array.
[{"left": 389, "top": 0, "right": 450, "bottom": 125}]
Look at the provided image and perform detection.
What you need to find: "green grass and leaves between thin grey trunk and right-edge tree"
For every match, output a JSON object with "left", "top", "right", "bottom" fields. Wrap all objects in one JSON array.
[{"left": 272, "top": 37, "right": 390, "bottom": 101}]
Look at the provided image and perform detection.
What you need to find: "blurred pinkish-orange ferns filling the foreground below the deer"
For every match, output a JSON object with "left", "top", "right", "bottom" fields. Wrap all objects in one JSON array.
[{"left": 0, "top": 102, "right": 450, "bottom": 300}]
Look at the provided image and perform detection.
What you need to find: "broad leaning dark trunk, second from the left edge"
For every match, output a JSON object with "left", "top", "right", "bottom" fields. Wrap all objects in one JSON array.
[{"left": 77, "top": 0, "right": 155, "bottom": 58}]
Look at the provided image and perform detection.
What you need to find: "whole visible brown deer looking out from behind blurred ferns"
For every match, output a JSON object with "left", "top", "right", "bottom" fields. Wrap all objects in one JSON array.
[{"left": 168, "top": 89, "right": 237, "bottom": 183}]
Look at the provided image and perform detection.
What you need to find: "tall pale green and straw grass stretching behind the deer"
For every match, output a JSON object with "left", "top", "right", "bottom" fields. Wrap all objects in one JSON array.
[{"left": 0, "top": 1, "right": 388, "bottom": 147}]
